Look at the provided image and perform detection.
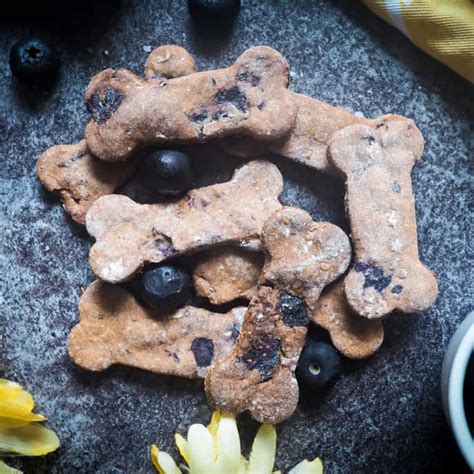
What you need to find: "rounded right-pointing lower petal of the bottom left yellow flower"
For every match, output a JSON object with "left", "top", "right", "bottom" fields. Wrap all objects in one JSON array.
[{"left": 0, "top": 424, "right": 59, "bottom": 456}]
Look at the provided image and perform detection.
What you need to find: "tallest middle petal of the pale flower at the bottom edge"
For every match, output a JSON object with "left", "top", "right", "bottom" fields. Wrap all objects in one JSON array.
[{"left": 215, "top": 413, "right": 240, "bottom": 473}]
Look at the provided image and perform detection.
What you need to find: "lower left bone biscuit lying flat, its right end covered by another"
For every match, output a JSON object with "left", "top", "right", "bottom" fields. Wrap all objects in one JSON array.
[{"left": 68, "top": 281, "right": 245, "bottom": 378}]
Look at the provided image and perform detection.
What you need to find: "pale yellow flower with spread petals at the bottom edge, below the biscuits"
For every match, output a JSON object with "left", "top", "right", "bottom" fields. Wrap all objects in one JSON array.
[{"left": 150, "top": 411, "right": 323, "bottom": 474}]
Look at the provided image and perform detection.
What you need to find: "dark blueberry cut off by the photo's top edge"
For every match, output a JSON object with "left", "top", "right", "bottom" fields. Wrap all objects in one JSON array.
[{"left": 188, "top": 0, "right": 240, "bottom": 29}]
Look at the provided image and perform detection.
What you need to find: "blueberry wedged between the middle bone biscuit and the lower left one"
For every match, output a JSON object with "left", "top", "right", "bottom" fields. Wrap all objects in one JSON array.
[{"left": 133, "top": 265, "right": 191, "bottom": 312}]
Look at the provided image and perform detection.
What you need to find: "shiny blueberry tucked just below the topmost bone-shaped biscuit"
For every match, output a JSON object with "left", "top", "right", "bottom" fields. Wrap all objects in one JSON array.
[{"left": 144, "top": 150, "right": 194, "bottom": 196}]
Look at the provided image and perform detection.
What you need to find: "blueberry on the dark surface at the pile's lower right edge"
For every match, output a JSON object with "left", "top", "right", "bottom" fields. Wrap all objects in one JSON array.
[{"left": 296, "top": 339, "right": 342, "bottom": 389}]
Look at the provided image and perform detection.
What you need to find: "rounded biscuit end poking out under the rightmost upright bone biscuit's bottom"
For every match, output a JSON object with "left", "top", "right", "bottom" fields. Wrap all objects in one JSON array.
[{"left": 313, "top": 279, "right": 384, "bottom": 359}]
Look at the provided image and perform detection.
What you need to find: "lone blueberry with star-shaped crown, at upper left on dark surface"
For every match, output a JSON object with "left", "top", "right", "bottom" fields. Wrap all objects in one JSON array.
[{"left": 10, "top": 38, "right": 59, "bottom": 86}]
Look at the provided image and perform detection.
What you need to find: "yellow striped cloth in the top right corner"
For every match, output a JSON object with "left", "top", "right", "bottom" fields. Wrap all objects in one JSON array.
[{"left": 362, "top": 0, "right": 474, "bottom": 82}]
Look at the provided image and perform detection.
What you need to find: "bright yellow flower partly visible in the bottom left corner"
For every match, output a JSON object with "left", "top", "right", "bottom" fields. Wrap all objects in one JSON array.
[{"left": 0, "top": 379, "right": 59, "bottom": 474}]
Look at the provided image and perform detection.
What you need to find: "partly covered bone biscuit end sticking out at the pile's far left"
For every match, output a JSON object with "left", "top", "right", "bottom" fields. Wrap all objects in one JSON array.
[{"left": 37, "top": 140, "right": 135, "bottom": 224}]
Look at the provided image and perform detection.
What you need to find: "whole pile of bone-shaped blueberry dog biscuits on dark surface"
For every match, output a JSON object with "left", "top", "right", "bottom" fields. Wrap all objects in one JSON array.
[{"left": 38, "top": 46, "right": 437, "bottom": 423}]
